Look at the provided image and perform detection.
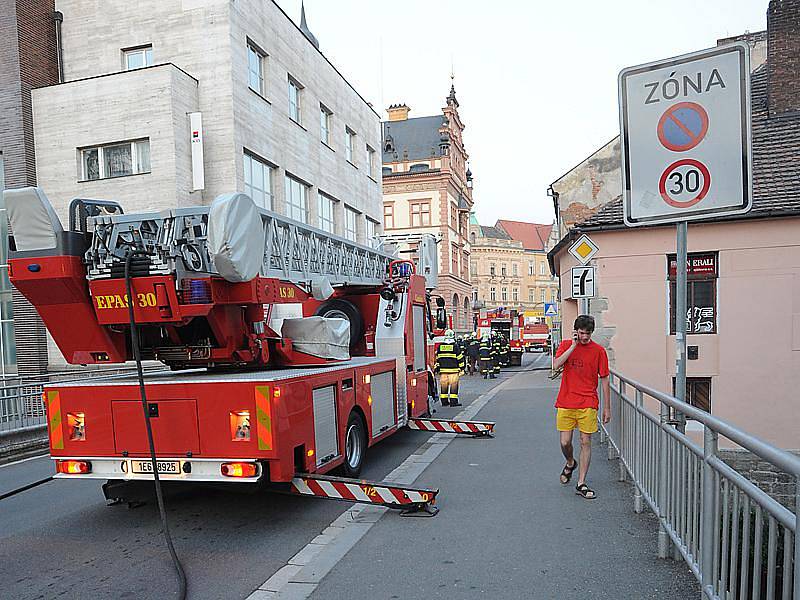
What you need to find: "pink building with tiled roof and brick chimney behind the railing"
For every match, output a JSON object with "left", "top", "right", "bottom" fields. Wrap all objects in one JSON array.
[{"left": 549, "top": 7, "right": 800, "bottom": 449}]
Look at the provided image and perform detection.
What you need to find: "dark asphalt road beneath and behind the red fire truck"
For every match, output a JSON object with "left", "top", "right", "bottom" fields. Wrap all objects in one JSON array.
[{"left": 0, "top": 355, "right": 520, "bottom": 600}]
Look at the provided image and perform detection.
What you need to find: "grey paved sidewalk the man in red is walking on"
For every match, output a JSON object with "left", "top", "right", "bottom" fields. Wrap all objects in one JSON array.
[{"left": 310, "top": 358, "right": 699, "bottom": 600}]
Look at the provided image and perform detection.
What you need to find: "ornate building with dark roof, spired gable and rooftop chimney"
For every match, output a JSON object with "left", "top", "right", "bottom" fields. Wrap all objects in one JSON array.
[{"left": 383, "top": 86, "right": 473, "bottom": 331}]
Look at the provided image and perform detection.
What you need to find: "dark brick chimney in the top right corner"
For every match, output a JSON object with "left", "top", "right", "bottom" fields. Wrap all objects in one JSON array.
[{"left": 767, "top": 0, "right": 800, "bottom": 117}]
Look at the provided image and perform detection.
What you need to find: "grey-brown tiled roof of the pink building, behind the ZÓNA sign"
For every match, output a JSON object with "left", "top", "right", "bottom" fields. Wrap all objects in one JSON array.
[{"left": 577, "top": 64, "right": 800, "bottom": 230}]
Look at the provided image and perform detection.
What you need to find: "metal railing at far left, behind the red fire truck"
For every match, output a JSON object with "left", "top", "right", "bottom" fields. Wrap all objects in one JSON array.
[{"left": 0, "top": 365, "right": 164, "bottom": 433}]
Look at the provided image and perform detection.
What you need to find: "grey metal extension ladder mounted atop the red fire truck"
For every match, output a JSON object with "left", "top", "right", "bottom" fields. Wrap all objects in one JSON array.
[{"left": 85, "top": 192, "right": 396, "bottom": 286}]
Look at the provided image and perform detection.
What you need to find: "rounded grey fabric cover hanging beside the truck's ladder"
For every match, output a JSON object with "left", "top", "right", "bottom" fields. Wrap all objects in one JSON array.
[{"left": 208, "top": 193, "right": 264, "bottom": 283}]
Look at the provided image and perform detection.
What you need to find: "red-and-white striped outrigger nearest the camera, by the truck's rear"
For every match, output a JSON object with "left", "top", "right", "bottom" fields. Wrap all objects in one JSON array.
[{"left": 290, "top": 473, "right": 439, "bottom": 517}]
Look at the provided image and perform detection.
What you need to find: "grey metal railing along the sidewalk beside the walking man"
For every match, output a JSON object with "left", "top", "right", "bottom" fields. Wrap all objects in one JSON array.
[{"left": 601, "top": 371, "right": 800, "bottom": 600}]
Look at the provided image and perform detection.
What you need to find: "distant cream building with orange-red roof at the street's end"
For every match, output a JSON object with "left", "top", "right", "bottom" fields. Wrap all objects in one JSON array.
[{"left": 470, "top": 218, "right": 558, "bottom": 317}]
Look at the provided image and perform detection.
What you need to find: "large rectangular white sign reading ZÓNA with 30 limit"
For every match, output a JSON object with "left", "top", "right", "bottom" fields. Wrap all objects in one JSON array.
[{"left": 619, "top": 42, "right": 752, "bottom": 226}]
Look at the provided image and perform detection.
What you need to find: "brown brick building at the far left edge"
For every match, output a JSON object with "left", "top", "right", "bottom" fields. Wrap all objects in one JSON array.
[{"left": 0, "top": 0, "right": 60, "bottom": 376}]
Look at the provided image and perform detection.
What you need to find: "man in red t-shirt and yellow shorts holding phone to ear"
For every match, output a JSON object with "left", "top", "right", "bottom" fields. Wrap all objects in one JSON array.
[{"left": 553, "top": 315, "right": 611, "bottom": 500}]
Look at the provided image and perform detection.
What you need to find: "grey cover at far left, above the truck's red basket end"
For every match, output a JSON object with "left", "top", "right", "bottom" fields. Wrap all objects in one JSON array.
[{"left": 3, "top": 187, "right": 64, "bottom": 251}]
